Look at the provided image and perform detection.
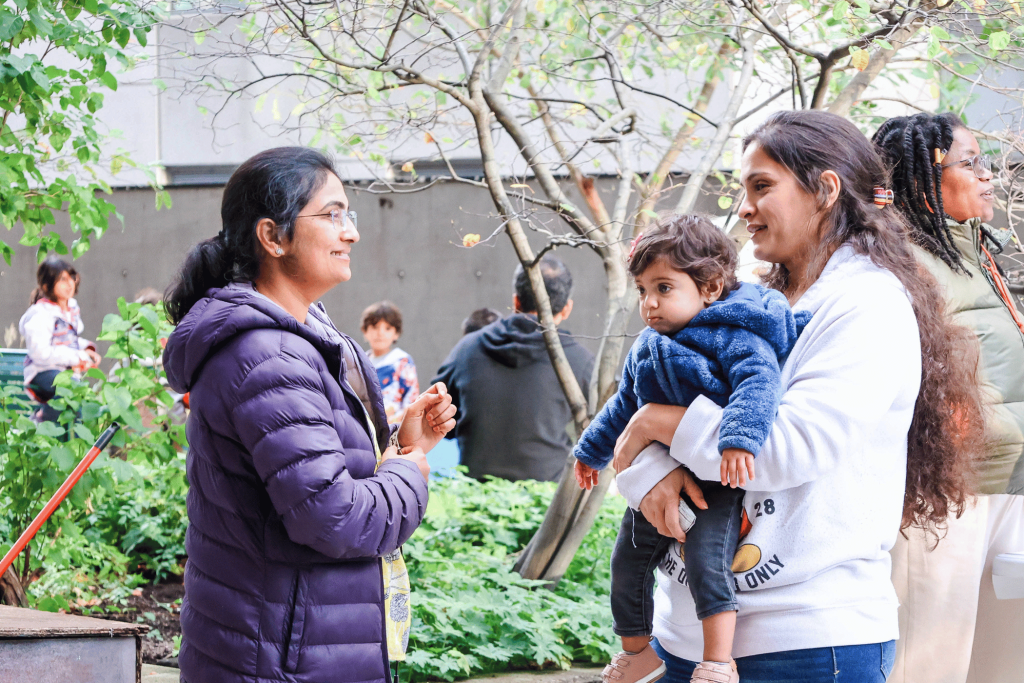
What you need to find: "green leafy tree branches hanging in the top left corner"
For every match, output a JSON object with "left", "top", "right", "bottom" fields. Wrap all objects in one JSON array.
[{"left": 0, "top": 0, "right": 160, "bottom": 264}]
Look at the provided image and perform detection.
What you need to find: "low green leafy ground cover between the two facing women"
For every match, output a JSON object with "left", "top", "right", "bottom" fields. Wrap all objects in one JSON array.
[{"left": 402, "top": 476, "right": 626, "bottom": 681}]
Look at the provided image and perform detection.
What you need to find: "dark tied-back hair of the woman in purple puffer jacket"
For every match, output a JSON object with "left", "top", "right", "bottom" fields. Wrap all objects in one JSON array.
[{"left": 164, "top": 147, "right": 337, "bottom": 325}]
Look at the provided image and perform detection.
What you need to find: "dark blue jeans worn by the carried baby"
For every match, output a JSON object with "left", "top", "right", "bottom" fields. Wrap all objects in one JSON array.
[{"left": 611, "top": 480, "right": 743, "bottom": 636}]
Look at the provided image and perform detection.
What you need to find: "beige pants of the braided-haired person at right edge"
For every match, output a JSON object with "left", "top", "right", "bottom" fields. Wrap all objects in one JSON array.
[{"left": 889, "top": 496, "right": 1024, "bottom": 683}]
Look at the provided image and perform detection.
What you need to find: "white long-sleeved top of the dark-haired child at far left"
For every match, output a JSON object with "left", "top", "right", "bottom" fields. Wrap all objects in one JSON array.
[{"left": 17, "top": 299, "right": 96, "bottom": 385}]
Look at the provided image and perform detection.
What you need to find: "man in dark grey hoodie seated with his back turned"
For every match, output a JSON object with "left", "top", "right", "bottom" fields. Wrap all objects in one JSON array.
[{"left": 433, "top": 256, "right": 594, "bottom": 481}]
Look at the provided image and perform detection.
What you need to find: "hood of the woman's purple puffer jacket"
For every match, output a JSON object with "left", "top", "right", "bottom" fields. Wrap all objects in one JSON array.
[{"left": 164, "top": 284, "right": 360, "bottom": 393}]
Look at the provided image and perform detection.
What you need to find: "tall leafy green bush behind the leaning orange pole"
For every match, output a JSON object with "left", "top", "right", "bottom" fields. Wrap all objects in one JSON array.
[{"left": 0, "top": 299, "right": 185, "bottom": 593}]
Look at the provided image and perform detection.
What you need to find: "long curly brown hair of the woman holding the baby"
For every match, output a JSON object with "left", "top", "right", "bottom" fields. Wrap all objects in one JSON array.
[{"left": 743, "top": 111, "right": 984, "bottom": 535}]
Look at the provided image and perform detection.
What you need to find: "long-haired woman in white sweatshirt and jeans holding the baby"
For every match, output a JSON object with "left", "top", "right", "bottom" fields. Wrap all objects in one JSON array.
[{"left": 616, "top": 111, "right": 982, "bottom": 683}]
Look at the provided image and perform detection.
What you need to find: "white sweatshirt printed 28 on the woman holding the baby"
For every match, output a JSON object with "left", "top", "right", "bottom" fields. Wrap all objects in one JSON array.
[{"left": 618, "top": 247, "right": 921, "bottom": 661}]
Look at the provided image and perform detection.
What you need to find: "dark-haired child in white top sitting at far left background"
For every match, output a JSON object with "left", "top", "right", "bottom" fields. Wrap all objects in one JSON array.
[{"left": 17, "top": 258, "right": 100, "bottom": 421}]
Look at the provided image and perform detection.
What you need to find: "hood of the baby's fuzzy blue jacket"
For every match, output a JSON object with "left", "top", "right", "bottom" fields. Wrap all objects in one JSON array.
[{"left": 683, "top": 283, "right": 811, "bottom": 356}]
